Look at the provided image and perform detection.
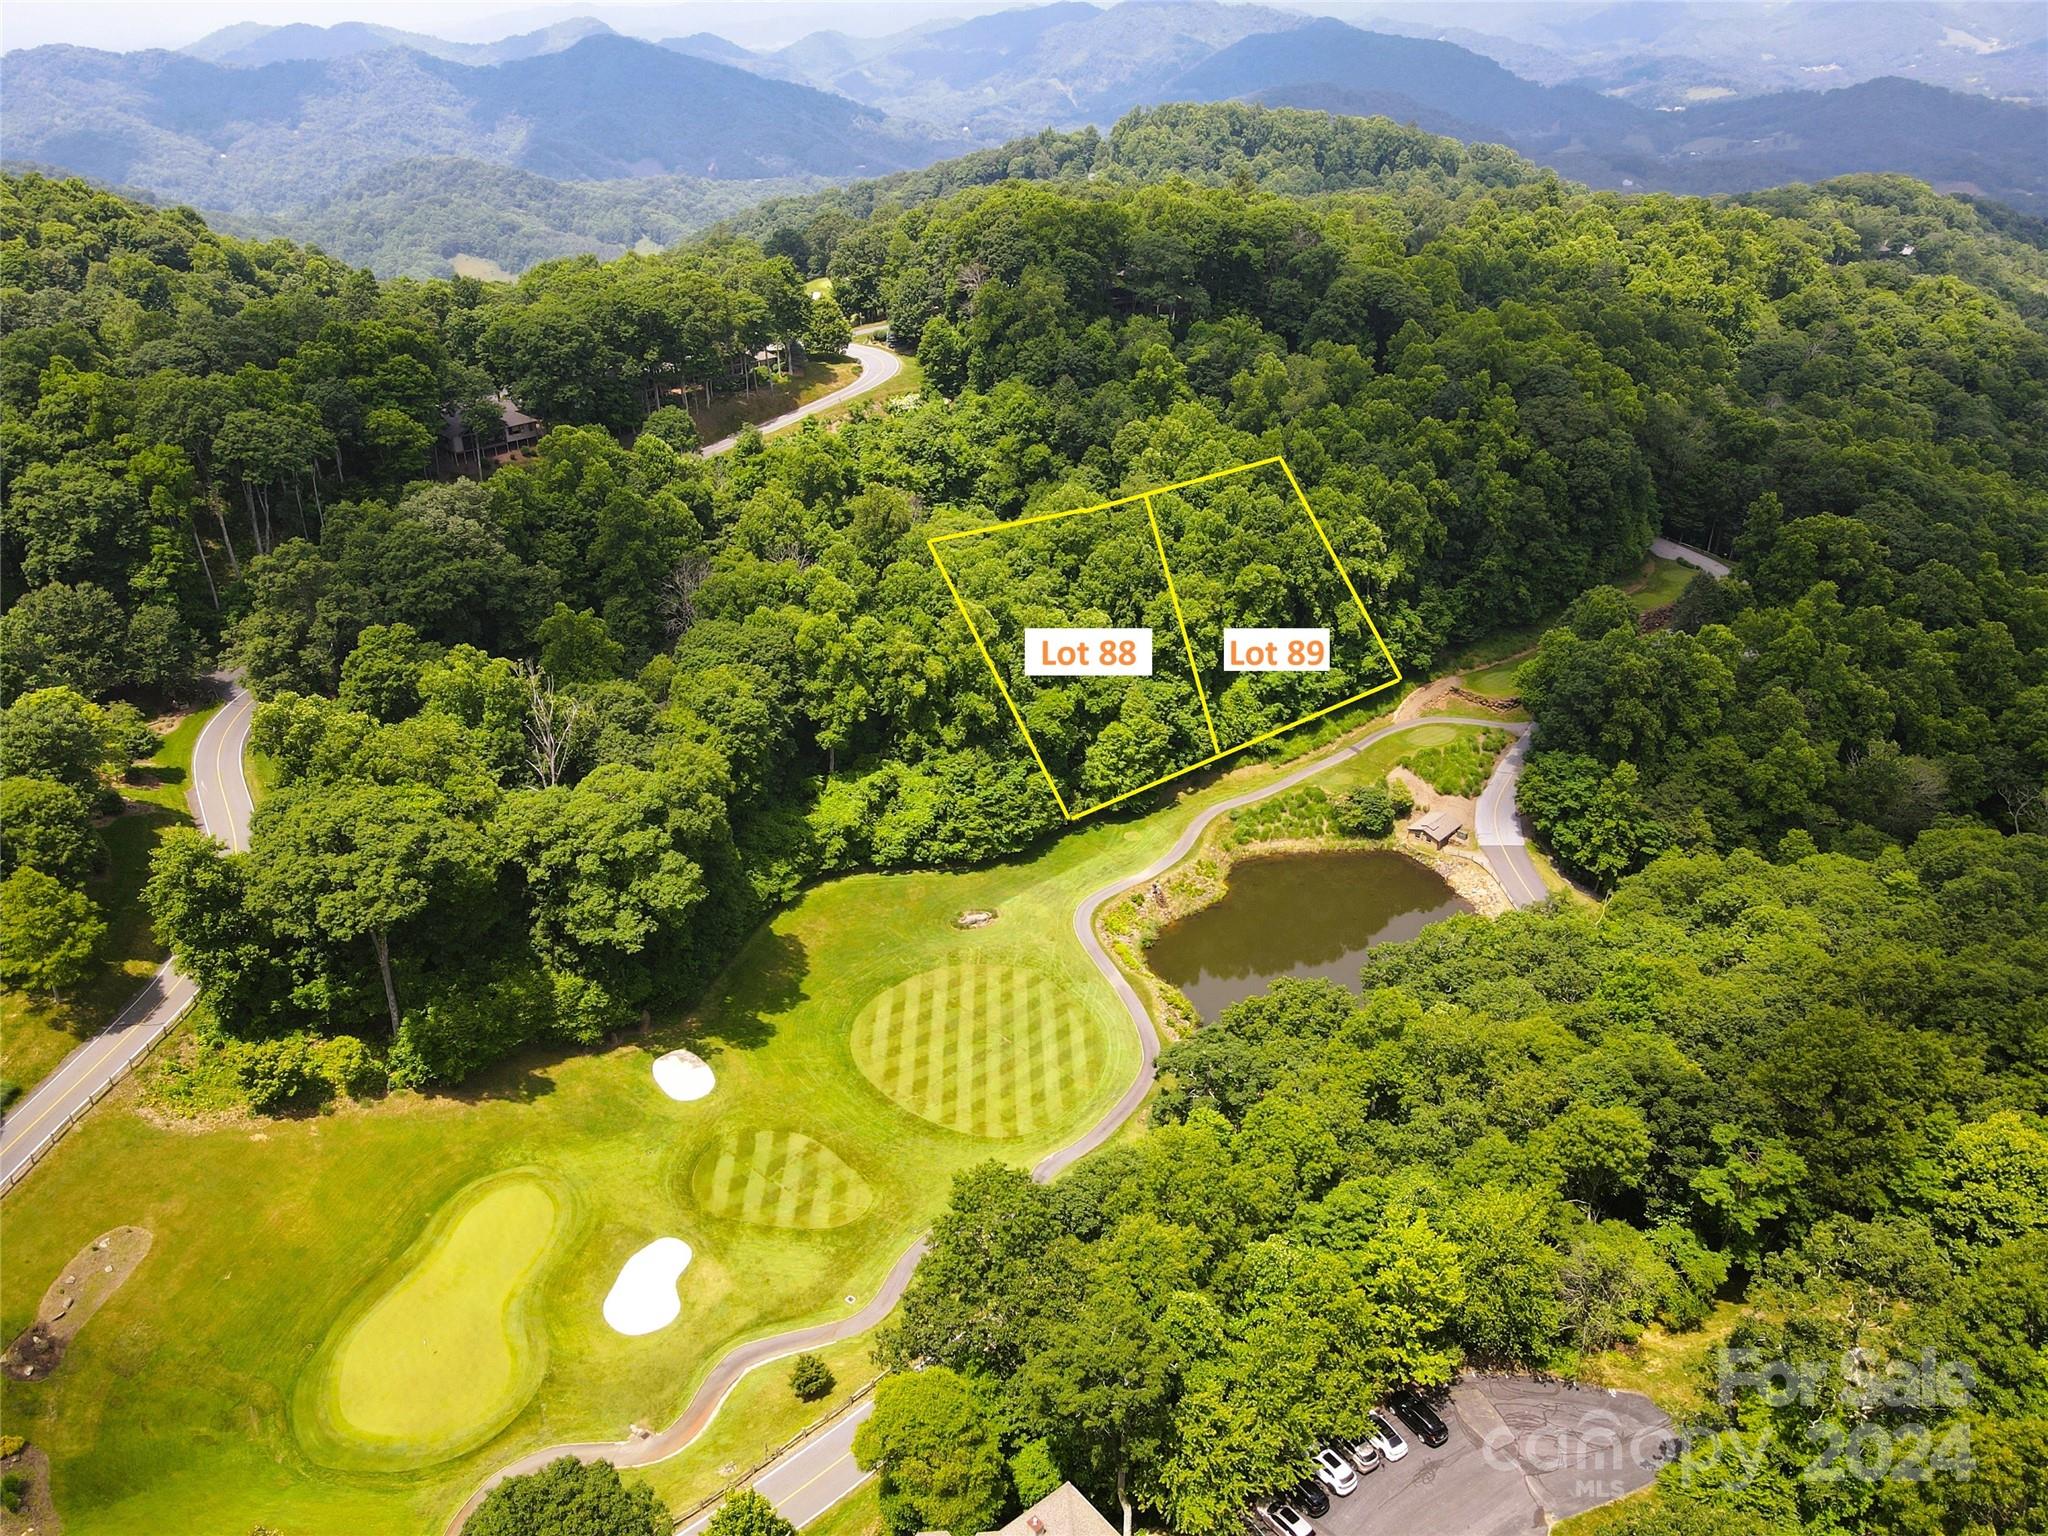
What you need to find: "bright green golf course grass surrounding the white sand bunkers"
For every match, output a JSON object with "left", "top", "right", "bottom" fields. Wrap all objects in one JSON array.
[{"left": 0, "top": 724, "right": 1399, "bottom": 1536}]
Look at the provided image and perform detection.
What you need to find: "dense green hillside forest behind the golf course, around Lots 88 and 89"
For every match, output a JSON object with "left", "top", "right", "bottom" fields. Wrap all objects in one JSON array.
[{"left": 0, "top": 106, "right": 2048, "bottom": 1146}]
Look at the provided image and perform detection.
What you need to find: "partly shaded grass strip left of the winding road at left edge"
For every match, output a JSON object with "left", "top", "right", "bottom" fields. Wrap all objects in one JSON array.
[{"left": 0, "top": 709, "right": 213, "bottom": 1098}]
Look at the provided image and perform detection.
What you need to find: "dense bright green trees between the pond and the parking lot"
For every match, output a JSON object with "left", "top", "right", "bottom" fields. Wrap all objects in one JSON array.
[{"left": 884, "top": 843, "right": 2048, "bottom": 1536}]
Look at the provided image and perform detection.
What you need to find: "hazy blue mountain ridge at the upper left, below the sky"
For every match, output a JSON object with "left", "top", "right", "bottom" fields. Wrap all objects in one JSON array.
[{"left": 0, "top": 33, "right": 948, "bottom": 213}]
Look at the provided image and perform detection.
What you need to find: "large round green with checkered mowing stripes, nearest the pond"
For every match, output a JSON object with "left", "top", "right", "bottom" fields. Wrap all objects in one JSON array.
[{"left": 852, "top": 961, "right": 1100, "bottom": 1141}]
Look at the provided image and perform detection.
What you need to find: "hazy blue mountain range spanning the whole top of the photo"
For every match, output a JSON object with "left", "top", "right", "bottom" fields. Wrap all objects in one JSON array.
[{"left": 0, "top": 0, "right": 2048, "bottom": 272}]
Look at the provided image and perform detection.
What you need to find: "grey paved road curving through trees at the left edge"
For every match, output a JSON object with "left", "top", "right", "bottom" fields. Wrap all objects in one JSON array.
[{"left": 0, "top": 678, "right": 254, "bottom": 1192}]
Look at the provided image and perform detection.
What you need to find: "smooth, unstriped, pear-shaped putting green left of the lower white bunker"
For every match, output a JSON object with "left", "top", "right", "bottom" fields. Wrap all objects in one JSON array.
[{"left": 297, "top": 1169, "right": 567, "bottom": 1470}]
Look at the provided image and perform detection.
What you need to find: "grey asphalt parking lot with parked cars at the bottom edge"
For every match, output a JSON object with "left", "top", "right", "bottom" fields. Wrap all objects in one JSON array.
[{"left": 1269, "top": 1374, "right": 1671, "bottom": 1536}]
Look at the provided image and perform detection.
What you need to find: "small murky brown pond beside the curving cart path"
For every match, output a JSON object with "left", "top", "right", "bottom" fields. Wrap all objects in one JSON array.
[{"left": 1145, "top": 850, "right": 1473, "bottom": 1020}]
